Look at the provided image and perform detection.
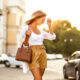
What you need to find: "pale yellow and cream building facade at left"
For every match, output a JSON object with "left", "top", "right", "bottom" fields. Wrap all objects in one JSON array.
[{"left": 0, "top": 0, "right": 26, "bottom": 55}]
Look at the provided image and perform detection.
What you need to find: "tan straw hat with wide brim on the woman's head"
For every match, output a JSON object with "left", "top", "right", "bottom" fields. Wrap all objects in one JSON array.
[{"left": 26, "top": 10, "right": 46, "bottom": 24}]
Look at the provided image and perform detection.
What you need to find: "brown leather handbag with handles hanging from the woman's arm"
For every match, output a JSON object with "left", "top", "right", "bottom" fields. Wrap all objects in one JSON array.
[{"left": 16, "top": 36, "right": 32, "bottom": 63}]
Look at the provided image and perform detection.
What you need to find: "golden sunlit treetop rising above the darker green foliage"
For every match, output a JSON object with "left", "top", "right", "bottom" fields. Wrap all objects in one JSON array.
[{"left": 52, "top": 20, "right": 72, "bottom": 32}]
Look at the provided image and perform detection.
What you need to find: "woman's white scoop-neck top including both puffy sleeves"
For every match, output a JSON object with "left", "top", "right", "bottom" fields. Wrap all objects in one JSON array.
[{"left": 21, "top": 24, "right": 56, "bottom": 46}]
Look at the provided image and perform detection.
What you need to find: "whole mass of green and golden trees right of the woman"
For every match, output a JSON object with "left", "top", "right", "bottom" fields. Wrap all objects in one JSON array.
[{"left": 44, "top": 21, "right": 80, "bottom": 55}]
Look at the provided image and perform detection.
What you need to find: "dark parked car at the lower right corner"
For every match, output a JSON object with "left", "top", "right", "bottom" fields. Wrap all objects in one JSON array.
[{"left": 63, "top": 51, "right": 80, "bottom": 80}]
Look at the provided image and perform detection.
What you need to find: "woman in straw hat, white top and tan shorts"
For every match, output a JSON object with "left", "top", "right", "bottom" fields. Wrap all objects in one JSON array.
[{"left": 21, "top": 10, "right": 56, "bottom": 80}]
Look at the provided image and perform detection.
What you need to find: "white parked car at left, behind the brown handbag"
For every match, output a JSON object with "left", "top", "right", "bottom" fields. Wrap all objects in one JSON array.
[{"left": 1, "top": 54, "right": 22, "bottom": 68}]
